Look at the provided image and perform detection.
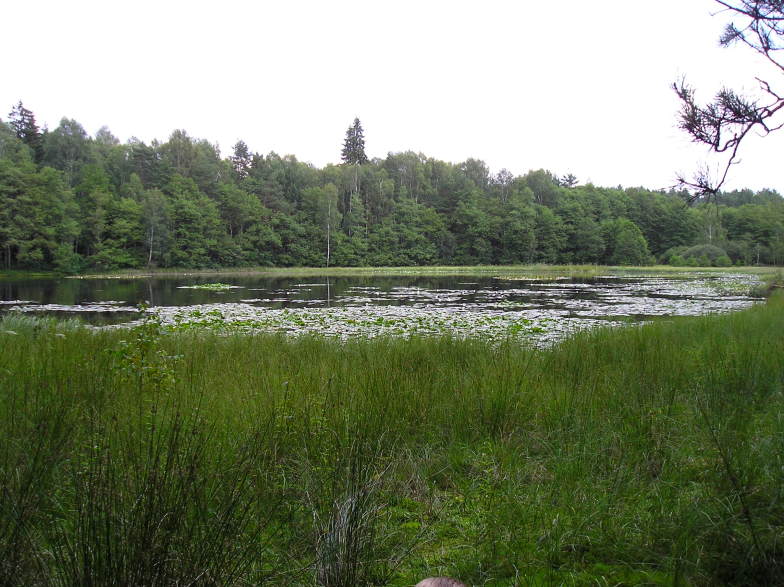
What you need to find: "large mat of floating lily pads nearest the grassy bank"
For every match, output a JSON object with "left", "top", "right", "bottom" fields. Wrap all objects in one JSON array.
[{"left": 127, "top": 275, "right": 756, "bottom": 346}]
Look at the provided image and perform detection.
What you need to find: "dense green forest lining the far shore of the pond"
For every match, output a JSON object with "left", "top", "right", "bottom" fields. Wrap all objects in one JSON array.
[{"left": 0, "top": 102, "right": 784, "bottom": 273}]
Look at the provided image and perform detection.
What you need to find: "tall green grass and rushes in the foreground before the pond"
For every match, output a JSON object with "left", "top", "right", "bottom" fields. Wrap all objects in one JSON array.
[{"left": 0, "top": 296, "right": 784, "bottom": 586}]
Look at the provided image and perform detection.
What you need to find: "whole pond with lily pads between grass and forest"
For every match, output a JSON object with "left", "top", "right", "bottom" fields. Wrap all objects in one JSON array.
[{"left": 0, "top": 272, "right": 759, "bottom": 344}]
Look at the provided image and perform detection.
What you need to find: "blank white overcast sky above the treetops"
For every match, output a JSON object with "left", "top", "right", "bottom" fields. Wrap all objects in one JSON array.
[{"left": 0, "top": 0, "right": 784, "bottom": 193}]
